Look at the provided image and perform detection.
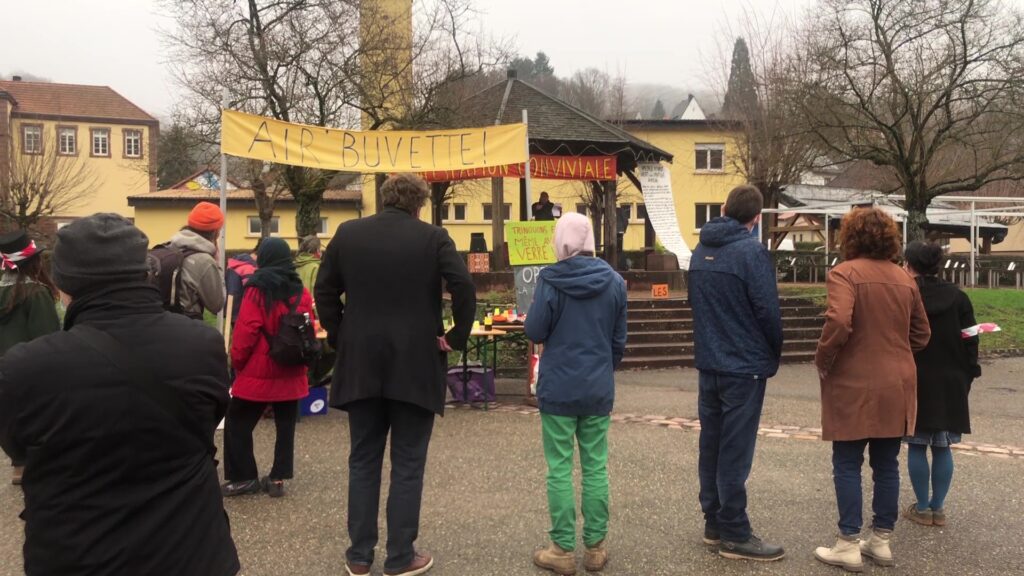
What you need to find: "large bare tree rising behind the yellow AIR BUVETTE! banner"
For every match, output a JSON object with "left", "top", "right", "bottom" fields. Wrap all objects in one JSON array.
[{"left": 164, "top": 0, "right": 512, "bottom": 235}]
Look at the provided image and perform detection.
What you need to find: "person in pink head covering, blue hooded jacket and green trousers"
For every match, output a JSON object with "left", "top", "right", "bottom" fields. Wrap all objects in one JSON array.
[{"left": 525, "top": 213, "right": 626, "bottom": 574}]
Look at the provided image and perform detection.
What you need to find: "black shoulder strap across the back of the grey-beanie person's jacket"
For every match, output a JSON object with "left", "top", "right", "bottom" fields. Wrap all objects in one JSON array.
[{"left": 69, "top": 324, "right": 216, "bottom": 455}]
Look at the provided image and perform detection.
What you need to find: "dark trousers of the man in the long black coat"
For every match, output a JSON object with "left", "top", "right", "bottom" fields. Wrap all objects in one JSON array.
[{"left": 345, "top": 398, "right": 434, "bottom": 571}]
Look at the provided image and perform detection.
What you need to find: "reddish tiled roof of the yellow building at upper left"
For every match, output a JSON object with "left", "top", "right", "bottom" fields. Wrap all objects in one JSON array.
[{"left": 0, "top": 80, "right": 157, "bottom": 122}]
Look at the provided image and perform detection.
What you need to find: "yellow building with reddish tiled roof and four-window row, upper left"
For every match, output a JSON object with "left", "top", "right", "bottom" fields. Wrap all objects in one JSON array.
[{"left": 0, "top": 77, "right": 160, "bottom": 225}]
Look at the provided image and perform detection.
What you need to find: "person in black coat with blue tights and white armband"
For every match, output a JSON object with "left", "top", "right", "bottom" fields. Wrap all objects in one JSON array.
[{"left": 903, "top": 242, "right": 981, "bottom": 526}]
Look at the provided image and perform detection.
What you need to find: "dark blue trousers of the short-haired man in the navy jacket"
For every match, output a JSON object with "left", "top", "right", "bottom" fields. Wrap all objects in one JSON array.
[{"left": 697, "top": 372, "right": 766, "bottom": 542}]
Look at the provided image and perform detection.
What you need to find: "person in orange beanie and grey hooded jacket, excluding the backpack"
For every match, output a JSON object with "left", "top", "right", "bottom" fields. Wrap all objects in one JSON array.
[{"left": 168, "top": 202, "right": 225, "bottom": 319}]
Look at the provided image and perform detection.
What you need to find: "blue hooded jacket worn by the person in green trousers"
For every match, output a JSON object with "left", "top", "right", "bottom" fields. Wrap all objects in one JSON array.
[{"left": 525, "top": 256, "right": 626, "bottom": 416}]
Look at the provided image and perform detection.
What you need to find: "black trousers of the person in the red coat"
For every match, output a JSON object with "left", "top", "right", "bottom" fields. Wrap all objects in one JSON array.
[{"left": 224, "top": 398, "right": 299, "bottom": 482}]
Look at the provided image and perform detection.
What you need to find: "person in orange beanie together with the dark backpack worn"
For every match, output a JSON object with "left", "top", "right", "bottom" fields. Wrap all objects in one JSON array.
[{"left": 150, "top": 202, "right": 225, "bottom": 320}]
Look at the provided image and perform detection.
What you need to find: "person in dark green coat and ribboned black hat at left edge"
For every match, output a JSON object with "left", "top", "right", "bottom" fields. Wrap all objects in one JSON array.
[{"left": 0, "top": 231, "right": 60, "bottom": 485}]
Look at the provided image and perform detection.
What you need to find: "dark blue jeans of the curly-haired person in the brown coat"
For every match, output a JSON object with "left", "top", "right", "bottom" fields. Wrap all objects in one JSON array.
[{"left": 833, "top": 438, "right": 900, "bottom": 536}]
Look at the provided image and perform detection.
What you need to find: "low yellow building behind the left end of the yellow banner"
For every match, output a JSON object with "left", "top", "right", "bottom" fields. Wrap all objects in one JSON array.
[{"left": 128, "top": 170, "right": 362, "bottom": 252}]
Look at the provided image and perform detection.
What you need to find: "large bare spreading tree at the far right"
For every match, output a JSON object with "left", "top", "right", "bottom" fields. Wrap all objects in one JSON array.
[{"left": 797, "top": 0, "right": 1024, "bottom": 239}]
